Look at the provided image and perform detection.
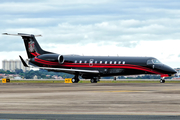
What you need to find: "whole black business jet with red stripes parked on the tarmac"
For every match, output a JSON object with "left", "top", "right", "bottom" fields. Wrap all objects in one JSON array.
[{"left": 3, "top": 33, "right": 176, "bottom": 83}]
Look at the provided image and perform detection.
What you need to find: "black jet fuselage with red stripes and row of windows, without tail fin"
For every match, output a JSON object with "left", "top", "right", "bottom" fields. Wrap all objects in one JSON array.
[{"left": 30, "top": 54, "right": 176, "bottom": 78}]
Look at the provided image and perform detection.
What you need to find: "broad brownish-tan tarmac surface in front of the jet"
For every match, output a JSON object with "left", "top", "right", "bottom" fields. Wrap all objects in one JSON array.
[{"left": 0, "top": 83, "right": 180, "bottom": 119}]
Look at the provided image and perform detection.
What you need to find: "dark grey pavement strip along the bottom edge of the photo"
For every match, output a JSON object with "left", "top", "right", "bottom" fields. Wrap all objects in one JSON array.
[{"left": 0, "top": 114, "right": 180, "bottom": 120}]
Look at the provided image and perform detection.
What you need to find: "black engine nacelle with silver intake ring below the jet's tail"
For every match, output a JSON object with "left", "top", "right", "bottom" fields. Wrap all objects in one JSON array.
[{"left": 36, "top": 54, "right": 64, "bottom": 64}]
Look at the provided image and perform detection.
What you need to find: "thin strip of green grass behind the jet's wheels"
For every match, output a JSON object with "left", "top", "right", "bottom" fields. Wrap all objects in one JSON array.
[{"left": 0, "top": 80, "right": 180, "bottom": 83}]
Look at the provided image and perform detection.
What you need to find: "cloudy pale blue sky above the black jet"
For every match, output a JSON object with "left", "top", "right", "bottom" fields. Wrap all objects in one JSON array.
[{"left": 0, "top": 0, "right": 180, "bottom": 68}]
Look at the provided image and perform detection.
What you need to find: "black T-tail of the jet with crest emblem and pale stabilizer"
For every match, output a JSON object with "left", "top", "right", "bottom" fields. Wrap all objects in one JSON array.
[{"left": 3, "top": 33, "right": 52, "bottom": 58}]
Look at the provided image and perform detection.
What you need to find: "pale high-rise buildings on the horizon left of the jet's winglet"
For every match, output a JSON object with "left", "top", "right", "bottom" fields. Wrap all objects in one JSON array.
[{"left": 2, "top": 60, "right": 30, "bottom": 72}]
